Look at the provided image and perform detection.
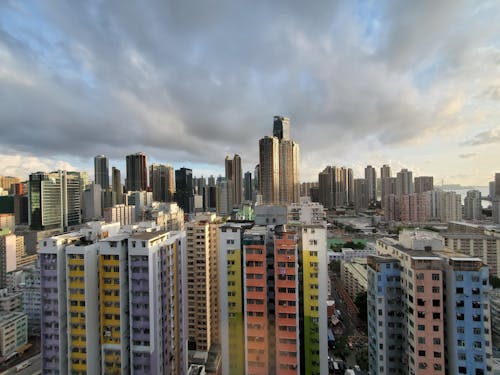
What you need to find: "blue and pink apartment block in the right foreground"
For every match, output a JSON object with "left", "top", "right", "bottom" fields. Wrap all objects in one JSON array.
[{"left": 368, "top": 230, "right": 491, "bottom": 375}]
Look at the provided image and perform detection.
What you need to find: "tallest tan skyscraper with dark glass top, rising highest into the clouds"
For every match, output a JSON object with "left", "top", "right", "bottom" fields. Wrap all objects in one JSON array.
[{"left": 255, "top": 116, "right": 300, "bottom": 205}]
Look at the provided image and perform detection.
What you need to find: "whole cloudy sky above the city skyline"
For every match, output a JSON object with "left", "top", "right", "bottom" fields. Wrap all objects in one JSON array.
[{"left": 0, "top": 0, "right": 500, "bottom": 186}]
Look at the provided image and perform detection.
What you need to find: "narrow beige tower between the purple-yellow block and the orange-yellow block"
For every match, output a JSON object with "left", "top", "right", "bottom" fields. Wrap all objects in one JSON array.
[{"left": 186, "top": 214, "right": 220, "bottom": 352}]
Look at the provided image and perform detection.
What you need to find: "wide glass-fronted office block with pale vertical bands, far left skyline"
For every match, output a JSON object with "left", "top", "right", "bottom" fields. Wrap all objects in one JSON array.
[{"left": 29, "top": 171, "right": 82, "bottom": 230}]
